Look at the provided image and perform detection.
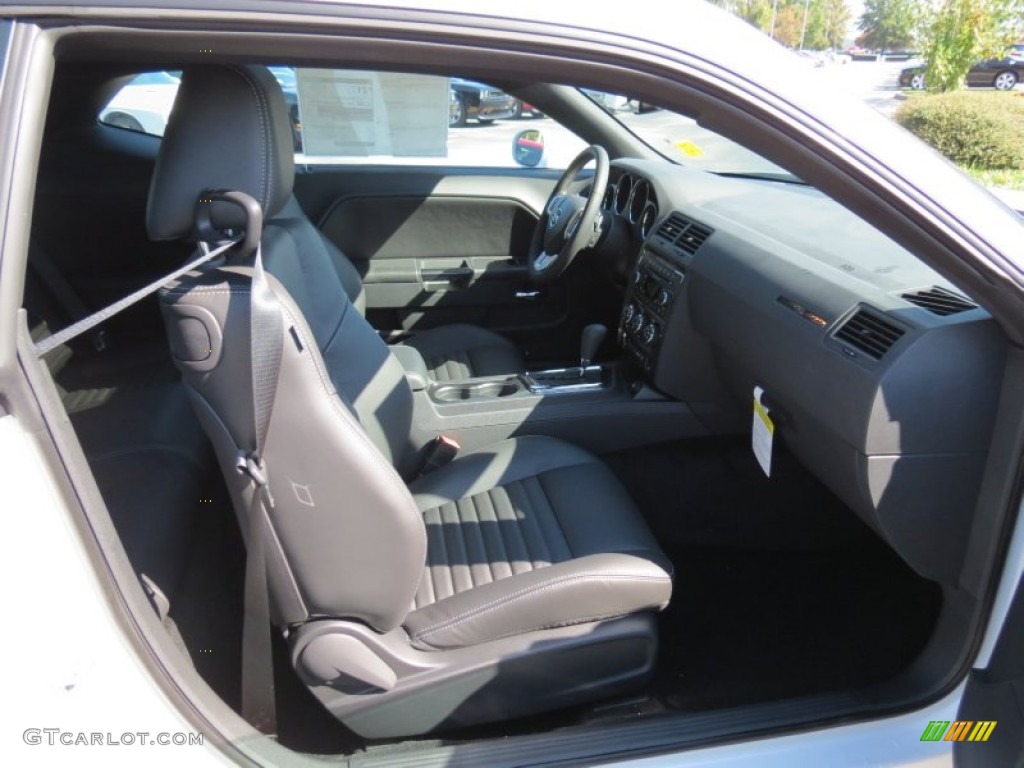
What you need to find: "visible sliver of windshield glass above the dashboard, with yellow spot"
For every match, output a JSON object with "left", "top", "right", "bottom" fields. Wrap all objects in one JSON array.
[{"left": 583, "top": 89, "right": 799, "bottom": 181}]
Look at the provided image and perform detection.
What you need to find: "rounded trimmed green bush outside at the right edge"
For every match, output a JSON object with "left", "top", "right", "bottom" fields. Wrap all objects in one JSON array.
[{"left": 896, "top": 91, "right": 1024, "bottom": 170}]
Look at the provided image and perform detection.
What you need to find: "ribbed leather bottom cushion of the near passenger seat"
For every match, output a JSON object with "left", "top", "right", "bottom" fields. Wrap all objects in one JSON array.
[{"left": 404, "top": 437, "right": 672, "bottom": 649}]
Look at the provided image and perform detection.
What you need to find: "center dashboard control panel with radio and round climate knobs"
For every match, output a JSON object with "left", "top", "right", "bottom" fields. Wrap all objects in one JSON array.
[{"left": 618, "top": 247, "right": 684, "bottom": 373}]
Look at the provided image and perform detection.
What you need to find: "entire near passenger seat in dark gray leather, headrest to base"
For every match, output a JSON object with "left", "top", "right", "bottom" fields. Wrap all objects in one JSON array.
[{"left": 148, "top": 67, "right": 672, "bottom": 737}]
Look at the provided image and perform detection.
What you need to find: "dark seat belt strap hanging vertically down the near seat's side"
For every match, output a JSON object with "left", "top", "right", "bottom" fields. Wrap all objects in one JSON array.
[{"left": 237, "top": 246, "right": 284, "bottom": 734}]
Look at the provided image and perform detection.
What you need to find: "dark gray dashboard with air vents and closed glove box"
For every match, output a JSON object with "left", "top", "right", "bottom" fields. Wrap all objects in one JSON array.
[{"left": 604, "top": 160, "right": 1006, "bottom": 581}]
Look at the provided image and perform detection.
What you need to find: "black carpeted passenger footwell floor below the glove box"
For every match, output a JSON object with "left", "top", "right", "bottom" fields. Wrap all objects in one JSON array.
[{"left": 604, "top": 438, "right": 941, "bottom": 710}]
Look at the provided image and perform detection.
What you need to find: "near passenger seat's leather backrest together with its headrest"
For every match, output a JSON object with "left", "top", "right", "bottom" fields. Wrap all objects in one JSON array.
[{"left": 146, "top": 65, "right": 426, "bottom": 630}]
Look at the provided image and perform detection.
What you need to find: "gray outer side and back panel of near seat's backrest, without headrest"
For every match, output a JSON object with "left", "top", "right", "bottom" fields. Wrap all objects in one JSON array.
[{"left": 160, "top": 267, "right": 426, "bottom": 630}]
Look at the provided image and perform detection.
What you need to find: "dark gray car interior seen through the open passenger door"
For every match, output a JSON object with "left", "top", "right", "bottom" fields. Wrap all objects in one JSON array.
[{"left": 24, "top": 18, "right": 1024, "bottom": 760}]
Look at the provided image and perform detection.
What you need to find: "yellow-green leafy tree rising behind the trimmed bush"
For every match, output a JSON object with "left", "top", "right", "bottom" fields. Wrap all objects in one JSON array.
[{"left": 924, "top": 0, "right": 1024, "bottom": 91}]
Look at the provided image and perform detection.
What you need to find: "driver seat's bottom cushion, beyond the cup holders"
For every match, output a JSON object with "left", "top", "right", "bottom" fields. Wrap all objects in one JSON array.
[{"left": 402, "top": 324, "right": 526, "bottom": 381}]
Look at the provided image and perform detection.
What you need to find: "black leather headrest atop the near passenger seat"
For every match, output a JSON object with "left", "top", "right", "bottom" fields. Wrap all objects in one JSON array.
[{"left": 145, "top": 65, "right": 295, "bottom": 240}]
